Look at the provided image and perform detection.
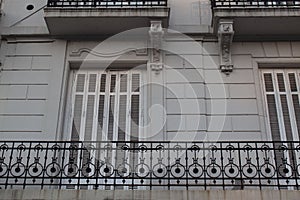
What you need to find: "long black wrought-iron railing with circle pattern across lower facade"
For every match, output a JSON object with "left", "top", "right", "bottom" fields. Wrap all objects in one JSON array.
[{"left": 0, "top": 141, "right": 300, "bottom": 190}]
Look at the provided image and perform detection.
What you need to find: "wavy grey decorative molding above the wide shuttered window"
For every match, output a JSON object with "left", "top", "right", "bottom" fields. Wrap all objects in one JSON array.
[{"left": 70, "top": 48, "right": 148, "bottom": 57}]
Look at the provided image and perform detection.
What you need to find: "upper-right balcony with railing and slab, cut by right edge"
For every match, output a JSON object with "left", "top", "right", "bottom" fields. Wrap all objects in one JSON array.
[{"left": 211, "top": 0, "right": 300, "bottom": 41}]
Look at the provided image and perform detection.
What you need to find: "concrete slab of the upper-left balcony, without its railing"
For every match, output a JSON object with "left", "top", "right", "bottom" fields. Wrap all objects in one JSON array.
[{"left": 44, "top": 7, "right": 169, "bottom": 36}]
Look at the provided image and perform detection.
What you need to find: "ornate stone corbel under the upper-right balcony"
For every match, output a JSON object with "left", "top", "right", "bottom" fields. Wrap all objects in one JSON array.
[{"left": 218, "top": 20, "right": 234, "bottom": 75}]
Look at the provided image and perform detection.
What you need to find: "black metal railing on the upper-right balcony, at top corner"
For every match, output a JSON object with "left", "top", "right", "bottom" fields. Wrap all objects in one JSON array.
[{"left": 211, "top": 0, "right": 300, "bottom": 8}]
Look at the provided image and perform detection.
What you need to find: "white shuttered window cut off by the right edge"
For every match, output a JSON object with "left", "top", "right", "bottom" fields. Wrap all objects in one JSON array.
[{"left": 262, "top": 69, "right": 300, "bottom": 141}]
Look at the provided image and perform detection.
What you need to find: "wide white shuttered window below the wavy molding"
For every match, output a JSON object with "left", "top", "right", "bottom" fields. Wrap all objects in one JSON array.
[{"left": 69, "top": 70, "right": 143, "bottom": 141}]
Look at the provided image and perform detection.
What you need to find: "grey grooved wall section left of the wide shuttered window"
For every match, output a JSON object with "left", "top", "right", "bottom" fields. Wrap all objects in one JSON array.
[{"left": 0, "top": 38, "right": 66, "bottom": 140}]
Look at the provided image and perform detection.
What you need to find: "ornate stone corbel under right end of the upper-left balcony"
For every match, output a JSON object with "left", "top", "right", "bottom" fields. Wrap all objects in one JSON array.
[{"left": 149, "top": 21, "right": 164, "bottom": 74}]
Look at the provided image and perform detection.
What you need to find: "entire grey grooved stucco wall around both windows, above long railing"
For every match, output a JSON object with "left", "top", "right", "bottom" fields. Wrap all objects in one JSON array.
[{"left": 0, "top": 38, "right": 300, "bottom": 140}]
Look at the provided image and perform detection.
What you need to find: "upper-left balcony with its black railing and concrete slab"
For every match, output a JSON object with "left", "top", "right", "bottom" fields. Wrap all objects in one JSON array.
[{"left": 44, "top": 0, "right": 170, "bottom": 37}]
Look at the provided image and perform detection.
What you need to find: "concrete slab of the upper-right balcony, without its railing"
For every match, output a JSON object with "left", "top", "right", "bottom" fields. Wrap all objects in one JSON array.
[{"left": 213, "top": 8, "right": 300, "bottom": 41}]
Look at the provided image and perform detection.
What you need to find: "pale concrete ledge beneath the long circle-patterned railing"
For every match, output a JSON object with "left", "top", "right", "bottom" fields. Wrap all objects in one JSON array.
[{"left": 0, "top": 189, "right": 300, "bottom": 200}]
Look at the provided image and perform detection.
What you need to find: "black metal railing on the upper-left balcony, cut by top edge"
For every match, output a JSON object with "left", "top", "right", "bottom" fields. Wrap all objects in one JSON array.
[{"left": 47, "top": 0, "right": 168, "bottom": 8}]
